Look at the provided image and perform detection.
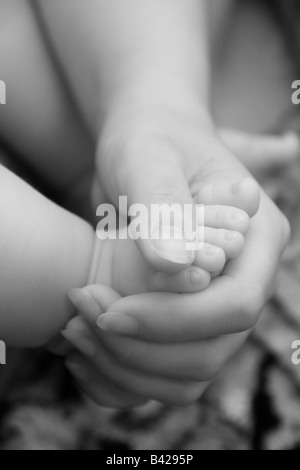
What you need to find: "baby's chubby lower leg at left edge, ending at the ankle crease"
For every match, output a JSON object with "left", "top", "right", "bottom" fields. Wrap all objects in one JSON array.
[{"left": 0, "top": 166, "right": 93, "bottom": 346}]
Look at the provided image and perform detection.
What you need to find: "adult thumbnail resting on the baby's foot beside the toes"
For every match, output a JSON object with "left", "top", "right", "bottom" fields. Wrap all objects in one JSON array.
[{"left": 151, "top": 226, "right": 194, "bottom": 264}]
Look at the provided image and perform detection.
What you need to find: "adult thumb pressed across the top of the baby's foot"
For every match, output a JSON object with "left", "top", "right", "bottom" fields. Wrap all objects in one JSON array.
[{"left": 122, "top": 142, "right": 196, "bottom": 273}]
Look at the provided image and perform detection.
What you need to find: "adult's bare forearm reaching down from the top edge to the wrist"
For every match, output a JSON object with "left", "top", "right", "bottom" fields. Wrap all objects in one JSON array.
[{"left": 35, "top": 0, "right": 209, "bottom": 136}]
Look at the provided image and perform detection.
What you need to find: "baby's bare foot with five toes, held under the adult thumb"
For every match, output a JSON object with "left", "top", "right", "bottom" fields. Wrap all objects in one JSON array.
[{"left": 90, "top": 178, "right": 259, "bottom": 296}]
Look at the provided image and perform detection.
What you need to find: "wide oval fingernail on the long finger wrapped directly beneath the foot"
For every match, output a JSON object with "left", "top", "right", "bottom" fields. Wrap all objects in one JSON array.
[{"left": 97, "top": 312, "right": 141, "bottom": 336}]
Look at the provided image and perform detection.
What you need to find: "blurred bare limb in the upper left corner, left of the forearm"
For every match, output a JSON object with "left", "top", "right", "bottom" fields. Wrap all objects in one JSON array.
[{"left": 0, "top": 0, "right": 93, "bottom": 189}]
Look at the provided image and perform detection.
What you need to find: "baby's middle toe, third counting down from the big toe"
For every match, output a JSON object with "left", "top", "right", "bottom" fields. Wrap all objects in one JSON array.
[{"left": 204, "top": 227, "right": 245, "bottom": 259}]
